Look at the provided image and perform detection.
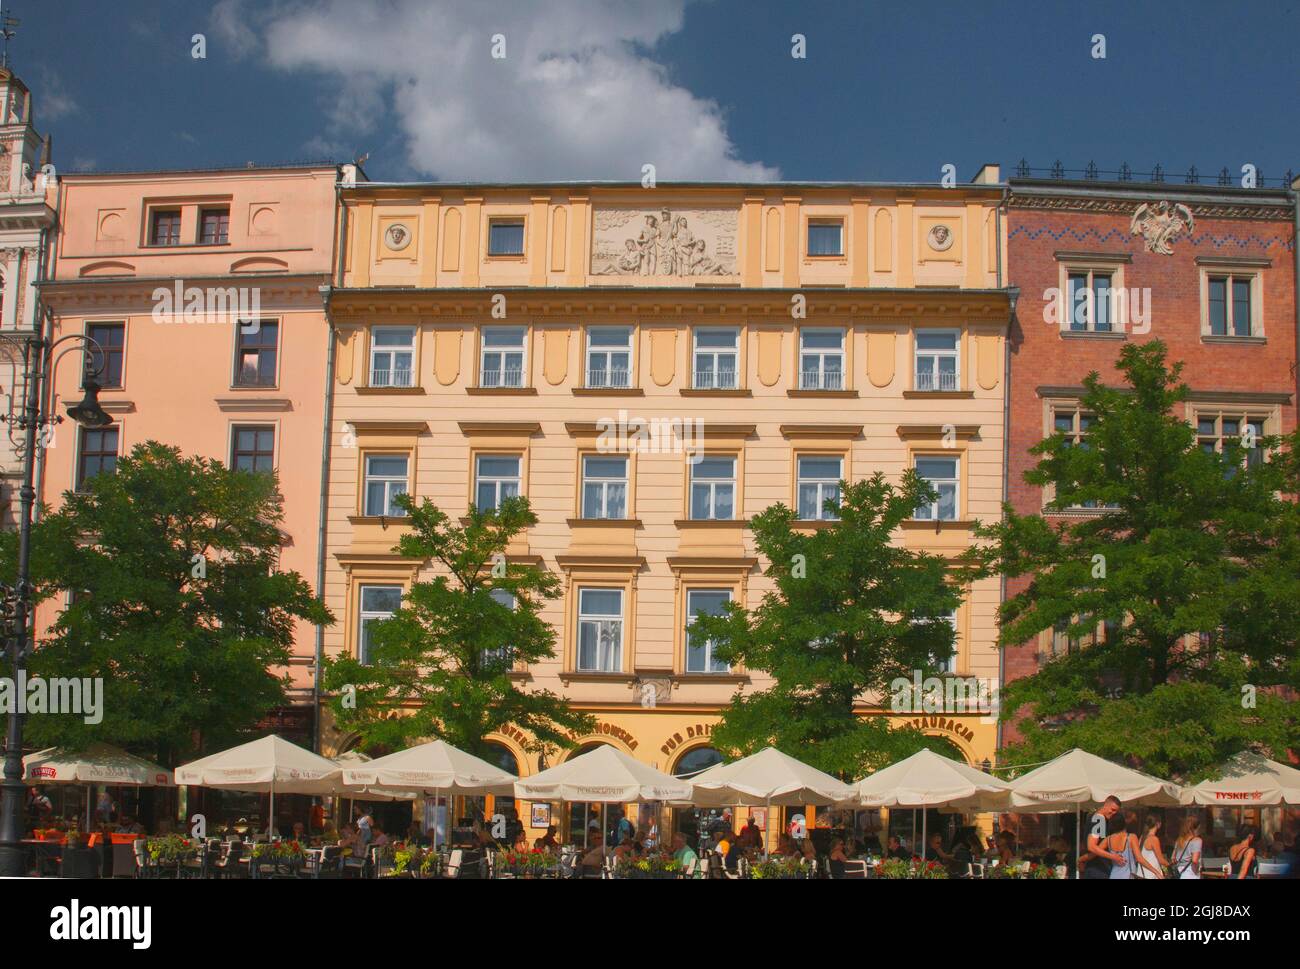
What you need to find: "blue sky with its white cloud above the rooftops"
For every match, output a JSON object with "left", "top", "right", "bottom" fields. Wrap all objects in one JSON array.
[{"left": 5, "top": 0, "right": 1300, "bottom": 181}]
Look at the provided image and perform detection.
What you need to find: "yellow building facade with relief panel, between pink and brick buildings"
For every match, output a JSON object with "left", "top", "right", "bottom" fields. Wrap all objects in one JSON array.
[{"left": 321, "top": 169, "right": 1010, "bottom": 838}]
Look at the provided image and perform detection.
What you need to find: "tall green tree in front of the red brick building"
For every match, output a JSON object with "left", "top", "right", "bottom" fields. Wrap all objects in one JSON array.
[{"left": 970, "top": 341, "right": 1300, "bottom": 777}]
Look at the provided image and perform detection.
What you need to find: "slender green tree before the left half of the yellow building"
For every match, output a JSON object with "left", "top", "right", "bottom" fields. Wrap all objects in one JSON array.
[{"left": 324, "top": 496, "right": 595, "bottom": 756}]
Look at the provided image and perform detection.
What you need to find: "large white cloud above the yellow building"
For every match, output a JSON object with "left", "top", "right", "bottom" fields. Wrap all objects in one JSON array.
[{"left": 213, "top": 0, "right": 779, "bottom": 181}]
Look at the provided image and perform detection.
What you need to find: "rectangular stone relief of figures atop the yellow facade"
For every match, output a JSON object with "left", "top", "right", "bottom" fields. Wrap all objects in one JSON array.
[{"left": 592, "top": 207, "right": 740, "bottom": 282}]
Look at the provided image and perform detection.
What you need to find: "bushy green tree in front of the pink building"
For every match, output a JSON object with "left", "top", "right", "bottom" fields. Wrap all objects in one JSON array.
[{"left": 0, "top": 441, "right": 332, "bottom": 765}]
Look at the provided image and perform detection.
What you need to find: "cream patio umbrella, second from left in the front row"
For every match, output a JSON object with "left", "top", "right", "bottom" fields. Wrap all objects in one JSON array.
[{"left": 176, "top": 734, "right": 342, "bottom": 831}]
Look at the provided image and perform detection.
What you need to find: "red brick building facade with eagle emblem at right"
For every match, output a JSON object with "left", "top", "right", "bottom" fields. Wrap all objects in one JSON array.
[{"left": 1002, "top": 178, "right": 1297, "bottom": 741}]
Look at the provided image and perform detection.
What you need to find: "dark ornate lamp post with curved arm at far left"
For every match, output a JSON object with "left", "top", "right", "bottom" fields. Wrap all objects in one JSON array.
[{"left": 0, "top": 333, "right": 113, "bottom": 877}]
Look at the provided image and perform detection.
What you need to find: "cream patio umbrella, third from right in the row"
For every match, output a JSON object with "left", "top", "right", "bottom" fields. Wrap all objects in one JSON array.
[{"left": 854, "top": 750, "right": 1011, "bottom": 858}]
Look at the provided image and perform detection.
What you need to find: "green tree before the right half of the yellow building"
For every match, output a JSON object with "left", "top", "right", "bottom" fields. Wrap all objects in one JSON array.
[{"left": 693, "top": 471, "right": 961, "bottom": 779}]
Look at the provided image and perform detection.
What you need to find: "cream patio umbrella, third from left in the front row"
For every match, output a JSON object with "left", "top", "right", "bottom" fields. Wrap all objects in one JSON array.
[{"left": 343, "top": 740, "right": 519, "bottom": 847}]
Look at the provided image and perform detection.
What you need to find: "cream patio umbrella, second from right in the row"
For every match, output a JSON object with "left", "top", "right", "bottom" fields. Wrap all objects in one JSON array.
[{"left": 1006, "top": 747, "right": 1184, "bottom": 877}]
